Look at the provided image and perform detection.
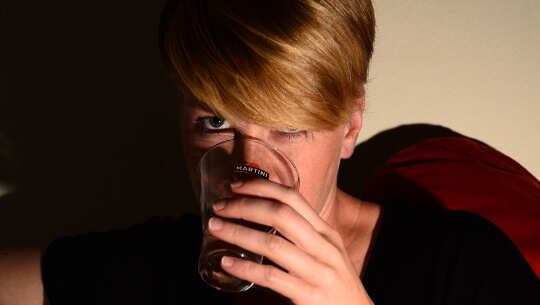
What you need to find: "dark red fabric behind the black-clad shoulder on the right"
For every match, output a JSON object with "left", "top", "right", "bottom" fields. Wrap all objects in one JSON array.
[{"left": 363, "top": 137, "right": 540, "bottom": 277}]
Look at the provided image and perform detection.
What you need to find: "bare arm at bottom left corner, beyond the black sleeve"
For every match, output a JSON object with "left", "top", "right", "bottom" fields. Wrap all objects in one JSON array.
[{"left": 0, "top": 247, "right": 47, "bottom": 305}]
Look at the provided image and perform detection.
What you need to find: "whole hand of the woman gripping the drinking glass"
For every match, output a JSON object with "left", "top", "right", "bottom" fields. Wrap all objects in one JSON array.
[{"left": 208, "top": 179, "right": 373, "bottom": 305}]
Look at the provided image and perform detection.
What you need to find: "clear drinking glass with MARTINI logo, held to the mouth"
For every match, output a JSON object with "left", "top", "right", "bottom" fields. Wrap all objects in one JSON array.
[{"left": 199, "top": 138, "right": 300, "bottom": 292}]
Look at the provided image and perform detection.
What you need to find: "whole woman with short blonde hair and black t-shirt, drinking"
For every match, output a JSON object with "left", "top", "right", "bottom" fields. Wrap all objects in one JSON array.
[{"left": 0, "top": 0, "right": 539, "bottom": 305}]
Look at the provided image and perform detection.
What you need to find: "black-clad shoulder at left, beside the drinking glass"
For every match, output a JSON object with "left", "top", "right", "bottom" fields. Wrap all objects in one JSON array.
[{"left": 41, "top": 215, "right": 209, "bottom": 304}]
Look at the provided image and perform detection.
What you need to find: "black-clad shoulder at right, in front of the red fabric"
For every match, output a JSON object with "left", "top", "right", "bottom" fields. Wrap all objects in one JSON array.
[{"left": 371, "top": 200, "right": 540, "bottom": 304}]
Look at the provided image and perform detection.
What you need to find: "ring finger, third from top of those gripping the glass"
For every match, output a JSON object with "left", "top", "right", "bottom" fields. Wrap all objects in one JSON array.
[{"left": 208, "top": 217, "right": 326, "bottom": 279}]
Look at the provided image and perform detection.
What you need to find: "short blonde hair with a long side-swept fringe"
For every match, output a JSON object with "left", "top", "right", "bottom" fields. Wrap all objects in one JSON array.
[{"left": 160, "top": 0, "right": 375, "bottom": 130}]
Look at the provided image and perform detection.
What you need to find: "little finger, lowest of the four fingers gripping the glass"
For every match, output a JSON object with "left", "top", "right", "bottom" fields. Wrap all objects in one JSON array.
[{"left": 221, "top": 256, "right": 314, "bottom": 300}]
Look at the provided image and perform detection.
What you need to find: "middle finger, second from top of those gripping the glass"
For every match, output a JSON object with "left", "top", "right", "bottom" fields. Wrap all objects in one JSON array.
[{"left": 213, "top": 196, "right": 334, "bottom": 259}]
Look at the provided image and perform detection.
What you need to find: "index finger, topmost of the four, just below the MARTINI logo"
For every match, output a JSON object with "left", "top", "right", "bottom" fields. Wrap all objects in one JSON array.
[{"left": 231, "top": 178, "right": 338, "bottom": 244}]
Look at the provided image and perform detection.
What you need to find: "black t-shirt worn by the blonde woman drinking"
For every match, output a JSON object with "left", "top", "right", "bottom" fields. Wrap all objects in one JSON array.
[{"left": 42, "top": 199, "right": 540, "bottom": 305}]
